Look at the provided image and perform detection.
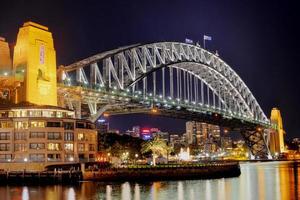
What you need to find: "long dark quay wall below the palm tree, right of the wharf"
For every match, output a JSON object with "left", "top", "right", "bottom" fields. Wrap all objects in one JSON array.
[{"left": 83, "top": 163, "right": 241, "bottom": 181}]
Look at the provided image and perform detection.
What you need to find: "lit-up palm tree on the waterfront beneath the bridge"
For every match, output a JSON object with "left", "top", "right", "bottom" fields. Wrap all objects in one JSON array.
[{"left": 141, "top": 137, "right": 170, "bottom": 166}]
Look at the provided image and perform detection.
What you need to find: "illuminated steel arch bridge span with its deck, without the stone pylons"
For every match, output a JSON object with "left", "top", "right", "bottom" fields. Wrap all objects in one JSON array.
[{"left": 57, "top": 42, "right": 272, "bottom": 158}]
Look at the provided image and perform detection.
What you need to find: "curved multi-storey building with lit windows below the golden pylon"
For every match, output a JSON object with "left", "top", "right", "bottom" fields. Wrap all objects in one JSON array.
[{"left": 0, "top": 106, "right": 97, "bottom": 165}]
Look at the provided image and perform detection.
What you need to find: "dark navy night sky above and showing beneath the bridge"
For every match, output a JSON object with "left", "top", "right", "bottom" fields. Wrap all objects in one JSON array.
[{"left": 0, "top": 0, "right": 300, "bottom": 138}]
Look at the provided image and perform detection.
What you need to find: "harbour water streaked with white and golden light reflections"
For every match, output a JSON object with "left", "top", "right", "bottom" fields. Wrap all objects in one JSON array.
[{"left": 0, "top": 162, "right": 300, "bottom": 200}]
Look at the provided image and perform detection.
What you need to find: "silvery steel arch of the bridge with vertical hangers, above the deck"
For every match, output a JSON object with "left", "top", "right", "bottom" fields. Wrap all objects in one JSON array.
[{"left": 60, "top": 42, "right": 269, "bottom": 124}]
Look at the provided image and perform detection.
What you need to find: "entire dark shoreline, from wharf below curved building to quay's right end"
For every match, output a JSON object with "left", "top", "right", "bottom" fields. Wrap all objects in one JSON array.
[{"left": 0, "top": 162, "right": 241, "bottom": 185}]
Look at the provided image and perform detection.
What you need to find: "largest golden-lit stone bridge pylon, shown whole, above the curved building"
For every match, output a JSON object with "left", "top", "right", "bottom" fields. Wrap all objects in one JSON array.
[{"left": 13, "top": 22, "right": 57, "bottom": 106}]
